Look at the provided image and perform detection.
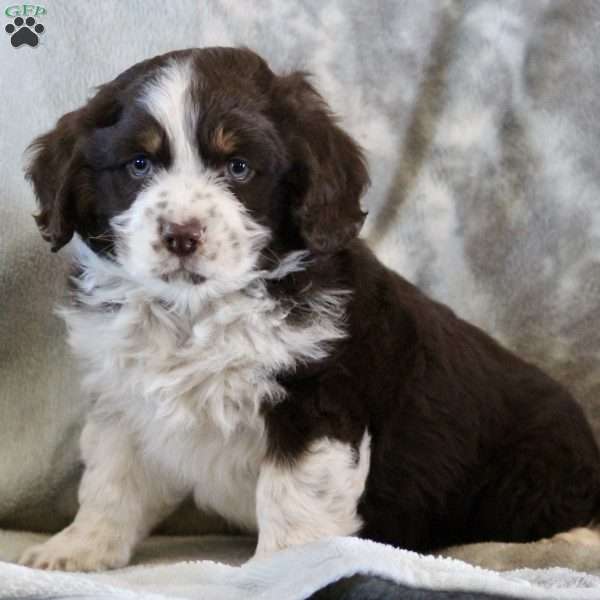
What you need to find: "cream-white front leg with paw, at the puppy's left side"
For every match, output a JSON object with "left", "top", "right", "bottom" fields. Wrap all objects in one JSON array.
[{"left": 19, "top": 422, "right": 184, "bottom": 571}]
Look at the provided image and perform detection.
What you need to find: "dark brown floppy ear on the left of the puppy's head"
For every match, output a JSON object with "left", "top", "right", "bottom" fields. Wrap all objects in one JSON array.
[{"left": 26, "top": 109, "right": 83, "bottom": 252}]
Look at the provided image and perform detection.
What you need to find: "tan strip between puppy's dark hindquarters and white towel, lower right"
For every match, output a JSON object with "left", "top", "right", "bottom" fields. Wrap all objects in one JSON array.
[{"left": 440, "top": 525, "right": 600, "bottom": 571}]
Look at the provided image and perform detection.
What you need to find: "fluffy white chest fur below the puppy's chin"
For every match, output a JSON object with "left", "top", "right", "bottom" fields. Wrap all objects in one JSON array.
[{"left": 63, "top": 244, "right": 344, "bottom": 528}]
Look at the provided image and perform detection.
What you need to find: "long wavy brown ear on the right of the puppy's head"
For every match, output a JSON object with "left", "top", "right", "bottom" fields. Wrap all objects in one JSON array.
[{"left": 275, "top": 72, "right": 369, "bottom": 253}]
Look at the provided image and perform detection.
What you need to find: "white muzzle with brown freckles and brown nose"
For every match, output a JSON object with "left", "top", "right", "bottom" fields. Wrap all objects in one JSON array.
[{"left": 112, "top": 172, "right": 269, "bottom": 285}]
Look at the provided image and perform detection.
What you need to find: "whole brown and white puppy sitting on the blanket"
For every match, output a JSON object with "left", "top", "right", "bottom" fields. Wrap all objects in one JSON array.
[{"left": 21, "top": 48, "right": 600, "bottom": 570}]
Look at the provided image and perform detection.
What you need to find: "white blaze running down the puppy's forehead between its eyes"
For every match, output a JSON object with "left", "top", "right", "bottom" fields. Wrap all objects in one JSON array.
[{"left": 140, "top": 59, "right": 201, "bottom": 171}]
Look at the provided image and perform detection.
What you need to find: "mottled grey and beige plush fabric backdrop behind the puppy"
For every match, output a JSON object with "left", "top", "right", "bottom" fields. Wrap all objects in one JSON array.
[{"left": 0, "top": 0, "right": 600, "bottom": 530}]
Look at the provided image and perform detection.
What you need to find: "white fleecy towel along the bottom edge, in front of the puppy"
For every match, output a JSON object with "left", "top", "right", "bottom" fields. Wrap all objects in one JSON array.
[{"left": 0, "top": 538, "right": 600, "bottom": 600}]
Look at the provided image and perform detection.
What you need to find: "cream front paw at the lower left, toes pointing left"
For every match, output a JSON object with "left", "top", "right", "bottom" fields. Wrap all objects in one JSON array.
[{"left": 19, "top": 525, "right": 130, "bottom": 571}]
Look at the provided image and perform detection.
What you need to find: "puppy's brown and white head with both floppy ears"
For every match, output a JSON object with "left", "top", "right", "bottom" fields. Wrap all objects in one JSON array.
[{"left": 27, "top": 48, "right": 368, "bottom": 296}]
